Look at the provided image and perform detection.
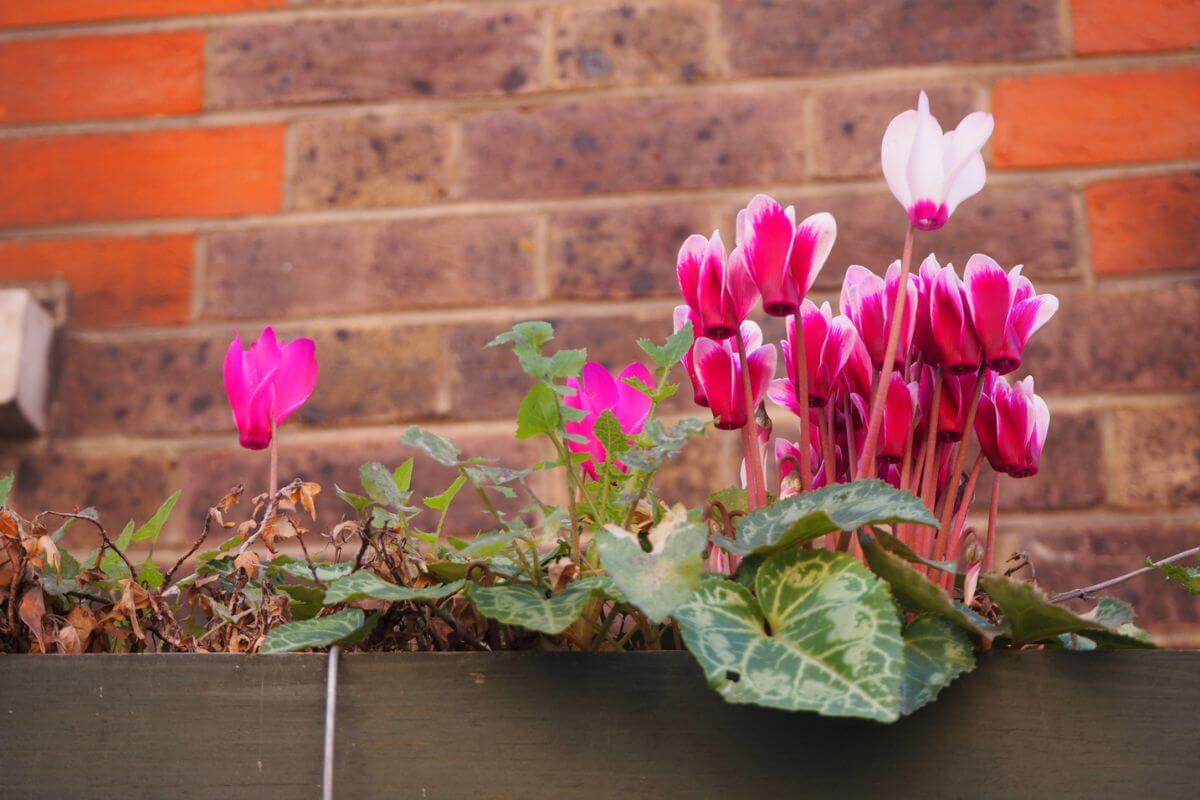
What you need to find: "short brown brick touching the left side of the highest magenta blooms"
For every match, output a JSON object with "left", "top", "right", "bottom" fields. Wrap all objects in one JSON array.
[{"left": 548, "top": 204, "right": 713, "bottom": 300}]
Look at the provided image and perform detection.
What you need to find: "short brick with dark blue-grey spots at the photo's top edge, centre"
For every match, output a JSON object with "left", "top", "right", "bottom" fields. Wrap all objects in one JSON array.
[{"left": 554, "top": 0, "right": 713, "bottom": 88}]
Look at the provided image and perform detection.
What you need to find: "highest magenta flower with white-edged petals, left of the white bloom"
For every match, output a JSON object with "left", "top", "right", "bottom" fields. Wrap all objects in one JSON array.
[{"left": 737, "top": 194, "right": 838, "bottom": 317}]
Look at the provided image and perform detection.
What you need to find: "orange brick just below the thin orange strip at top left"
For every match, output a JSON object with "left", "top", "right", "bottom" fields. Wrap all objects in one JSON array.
[{"left": 0, "top": 31, "right": 204, "bottom": 122}]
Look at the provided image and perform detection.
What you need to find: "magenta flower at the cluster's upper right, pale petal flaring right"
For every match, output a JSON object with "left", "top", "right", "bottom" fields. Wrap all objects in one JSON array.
[{"left": 962, "top": 253, "right": 1058, "bottom": 375}]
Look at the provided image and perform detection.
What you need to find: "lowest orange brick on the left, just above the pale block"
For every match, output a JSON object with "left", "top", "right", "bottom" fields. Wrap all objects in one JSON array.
[{"left": 0, "top": 234, "right": 196, "bottom": 327}]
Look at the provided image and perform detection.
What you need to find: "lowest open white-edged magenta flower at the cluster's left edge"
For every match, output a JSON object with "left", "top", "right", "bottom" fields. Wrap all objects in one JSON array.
[{"left": 692, "top": 320, "right": 776, "bottom": 431}]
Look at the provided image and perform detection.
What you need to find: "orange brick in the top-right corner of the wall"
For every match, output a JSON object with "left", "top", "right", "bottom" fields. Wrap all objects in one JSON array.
[{"left": 1070, "top": 0, "right": 1200, "bottom": 55}]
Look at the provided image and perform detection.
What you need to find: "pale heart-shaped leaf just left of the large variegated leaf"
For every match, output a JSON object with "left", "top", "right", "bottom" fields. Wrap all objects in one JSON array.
[{"left": 596, "top": 505, "right": 708, "bottom": 621}]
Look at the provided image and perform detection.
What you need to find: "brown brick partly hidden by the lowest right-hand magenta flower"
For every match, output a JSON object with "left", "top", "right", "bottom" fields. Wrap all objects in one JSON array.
[{"left": 1003, "top": 409, "right": 1105, "bottom": 511}]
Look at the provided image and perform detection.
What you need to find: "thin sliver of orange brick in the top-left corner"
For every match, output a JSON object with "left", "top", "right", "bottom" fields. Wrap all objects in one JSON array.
[{"left": 0, "top": 0, "right": 287, "bottom": 28}]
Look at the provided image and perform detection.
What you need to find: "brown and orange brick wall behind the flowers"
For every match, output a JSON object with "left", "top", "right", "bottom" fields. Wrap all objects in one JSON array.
[{"left": 0, "top": 0, "right": 1200, "bottom": 643}]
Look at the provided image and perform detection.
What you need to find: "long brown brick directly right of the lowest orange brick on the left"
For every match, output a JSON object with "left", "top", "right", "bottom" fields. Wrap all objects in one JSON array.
[{"left": 202, "top": 217, "right": 536, "bottom": 319}]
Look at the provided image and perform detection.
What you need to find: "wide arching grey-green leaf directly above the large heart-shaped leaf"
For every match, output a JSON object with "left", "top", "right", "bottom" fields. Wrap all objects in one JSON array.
[{"left": 713, "top": 479, "right": 937, "bottom": 555}]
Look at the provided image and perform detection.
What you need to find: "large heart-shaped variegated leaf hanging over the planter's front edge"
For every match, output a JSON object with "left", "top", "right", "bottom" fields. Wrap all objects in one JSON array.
[{"left": 674, "top": 551, "right": 904, "bottom": 722}]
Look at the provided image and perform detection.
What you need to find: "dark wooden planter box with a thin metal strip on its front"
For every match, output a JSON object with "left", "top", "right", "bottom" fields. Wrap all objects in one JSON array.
[{"left": 0, "top": 651, "right": 1200, "bottom": 800}]
